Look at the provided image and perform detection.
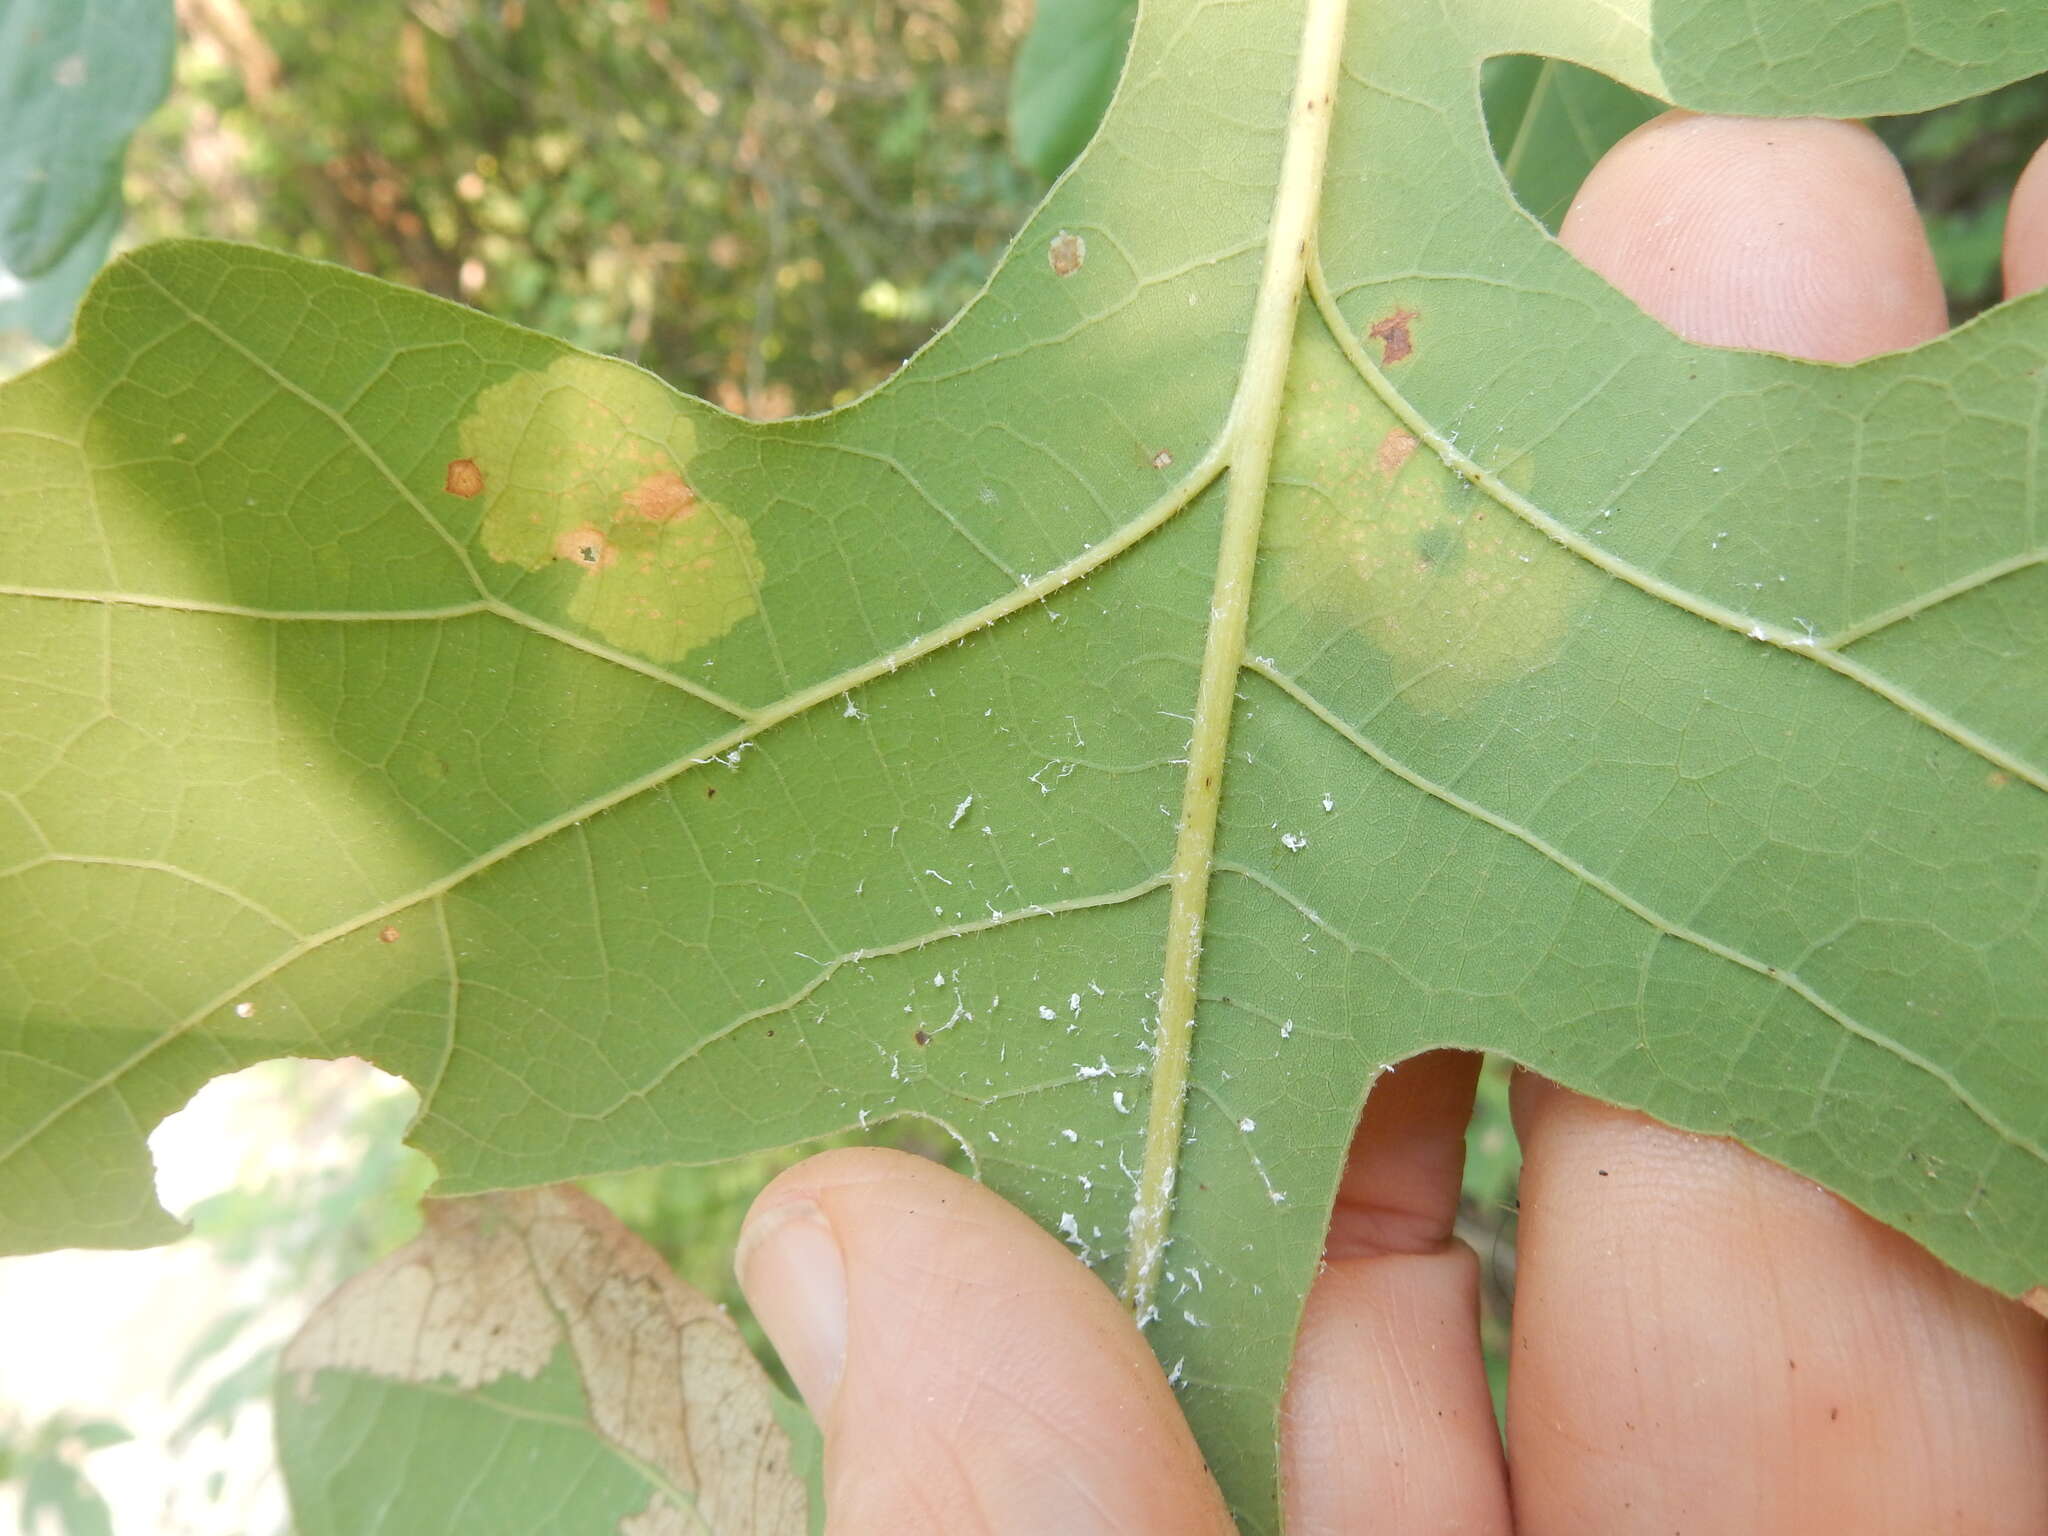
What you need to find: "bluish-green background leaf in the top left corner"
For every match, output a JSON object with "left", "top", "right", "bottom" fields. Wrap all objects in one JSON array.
[{"left": 0, "top": 0, "right": 176, "bottom": 344}]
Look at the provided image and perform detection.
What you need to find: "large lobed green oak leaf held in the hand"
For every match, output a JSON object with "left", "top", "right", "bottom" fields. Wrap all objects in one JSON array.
[{"left": 0, "top": 0, "right": 2048, "bottom": 1532}]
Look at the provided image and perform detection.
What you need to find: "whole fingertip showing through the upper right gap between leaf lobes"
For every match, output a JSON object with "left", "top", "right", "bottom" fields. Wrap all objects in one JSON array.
[{"left": 1559, "top": 113, "right": 1948, "bottom": 362}]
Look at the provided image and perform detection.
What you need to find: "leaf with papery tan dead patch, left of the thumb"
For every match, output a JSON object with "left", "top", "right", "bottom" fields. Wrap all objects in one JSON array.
[{"left": 276, "top": 1186, "right": 817, "bottom": 1536}]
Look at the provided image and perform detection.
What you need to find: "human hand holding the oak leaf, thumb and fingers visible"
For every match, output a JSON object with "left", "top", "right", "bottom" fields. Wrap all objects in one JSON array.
[{"left": 739, "top": 113, "right": 2048, "bottom": 1536}]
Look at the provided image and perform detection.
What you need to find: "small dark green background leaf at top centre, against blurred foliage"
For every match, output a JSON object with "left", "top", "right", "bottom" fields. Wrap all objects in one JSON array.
[{"left": 1010, "top": 0, "right": 1139, "bottom": 180}]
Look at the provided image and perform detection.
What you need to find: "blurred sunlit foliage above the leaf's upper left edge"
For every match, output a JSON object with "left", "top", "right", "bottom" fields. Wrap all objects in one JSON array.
[{"left": 131, "top": 0, "right": 1040, "bottom": 416}]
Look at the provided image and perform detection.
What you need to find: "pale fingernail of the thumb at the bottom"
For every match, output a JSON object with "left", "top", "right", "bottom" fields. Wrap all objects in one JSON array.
[{"left": 733, "top": 1200, "right": 846, "bottom": 1417}]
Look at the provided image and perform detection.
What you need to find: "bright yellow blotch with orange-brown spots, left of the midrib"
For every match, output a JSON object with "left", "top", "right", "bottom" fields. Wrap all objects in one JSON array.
[{"left": 461, "top": 356, "right": 762, "bottom": 662}]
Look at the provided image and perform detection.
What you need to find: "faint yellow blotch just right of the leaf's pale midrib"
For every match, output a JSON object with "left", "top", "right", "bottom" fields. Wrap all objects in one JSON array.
[{"left": 1264, "top": 319, "right": 1599, "bottom": 715}]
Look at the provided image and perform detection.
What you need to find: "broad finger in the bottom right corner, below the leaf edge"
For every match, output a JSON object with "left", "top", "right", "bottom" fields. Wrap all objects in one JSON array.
[{"left": 1507, "top": 1077, "right": 2048, "bottom": 1536}]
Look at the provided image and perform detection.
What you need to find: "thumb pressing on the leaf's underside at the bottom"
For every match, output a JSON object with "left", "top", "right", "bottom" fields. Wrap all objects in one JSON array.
[{"left": 733, "top": 1147, "right": 1233, "bottom": 1536}]
